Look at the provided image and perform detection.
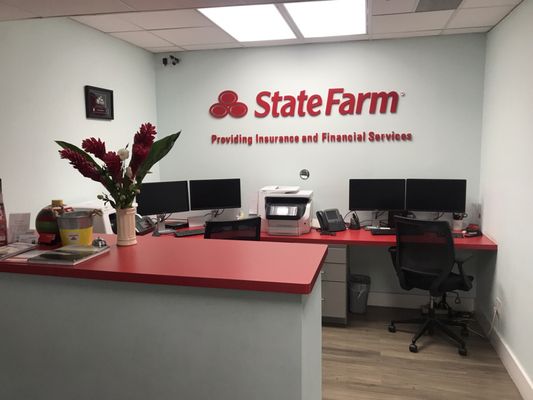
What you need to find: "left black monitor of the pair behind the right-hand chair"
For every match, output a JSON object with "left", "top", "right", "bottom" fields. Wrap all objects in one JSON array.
[{"left": 349, "top": 179, "right": 405, "bottom": 211}]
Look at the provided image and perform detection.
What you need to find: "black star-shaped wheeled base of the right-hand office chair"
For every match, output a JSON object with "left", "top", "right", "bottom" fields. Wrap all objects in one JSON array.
[{"left": 389, "top": 309, "right": 468, "bottom": 356}]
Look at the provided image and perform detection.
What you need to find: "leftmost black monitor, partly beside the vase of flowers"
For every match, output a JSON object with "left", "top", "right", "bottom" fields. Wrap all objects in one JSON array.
[{"left": 137, "top": 181, "right": 189, "bottom": 215}]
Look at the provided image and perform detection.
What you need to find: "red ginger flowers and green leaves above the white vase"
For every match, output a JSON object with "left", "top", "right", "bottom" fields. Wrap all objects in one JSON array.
[{"left": 56, "top": 123, "right": 181, "bottom": 209}]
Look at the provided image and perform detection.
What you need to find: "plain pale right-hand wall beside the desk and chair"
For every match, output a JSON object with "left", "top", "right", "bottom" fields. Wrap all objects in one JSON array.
[{"left": 477, "top": 0, "right": 533, "bottom": 392}]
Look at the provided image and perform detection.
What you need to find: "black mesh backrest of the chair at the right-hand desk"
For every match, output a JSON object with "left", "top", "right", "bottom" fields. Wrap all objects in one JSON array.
[{"left": 393, "top": 217, "right": 455, "bottom": 296}]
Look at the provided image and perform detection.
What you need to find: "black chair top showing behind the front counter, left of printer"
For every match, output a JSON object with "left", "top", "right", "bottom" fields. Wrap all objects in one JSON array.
[{"left": 204, "top": 217, "right": 261, "bottom": 240}]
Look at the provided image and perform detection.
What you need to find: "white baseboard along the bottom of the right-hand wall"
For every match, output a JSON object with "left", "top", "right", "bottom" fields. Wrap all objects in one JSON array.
[{"left": 477, "top": 313, "right": 533, "bottom": 400}]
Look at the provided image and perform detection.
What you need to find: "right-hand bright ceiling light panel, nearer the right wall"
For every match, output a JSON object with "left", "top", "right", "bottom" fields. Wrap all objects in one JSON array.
[{"left": 284, "top": 0, "right": 366, "bottom": 38}]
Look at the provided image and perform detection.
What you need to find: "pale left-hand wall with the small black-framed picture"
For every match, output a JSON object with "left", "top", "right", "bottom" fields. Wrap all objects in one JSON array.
[{"left": 0, "top": 19, "right": 158, "bottom": 220}]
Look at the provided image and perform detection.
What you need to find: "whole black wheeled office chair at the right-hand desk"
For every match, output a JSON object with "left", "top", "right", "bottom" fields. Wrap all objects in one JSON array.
[{"left": 389, "top": 217, "right": 474, "bottom": 356}]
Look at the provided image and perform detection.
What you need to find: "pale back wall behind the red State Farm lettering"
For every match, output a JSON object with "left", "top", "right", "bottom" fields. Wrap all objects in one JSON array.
[{"left": 155, "top": 35, "right": 485, "bottom": 296}]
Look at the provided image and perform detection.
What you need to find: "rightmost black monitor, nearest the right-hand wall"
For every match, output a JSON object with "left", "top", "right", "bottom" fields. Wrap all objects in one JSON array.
[{"left": 406, "top": 179, "right": 466, "bottom": 212}]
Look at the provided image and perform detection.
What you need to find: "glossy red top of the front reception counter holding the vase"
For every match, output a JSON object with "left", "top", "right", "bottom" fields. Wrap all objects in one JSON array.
[{"left": 0, "top": 235, "right": 327, "bottom": 294}]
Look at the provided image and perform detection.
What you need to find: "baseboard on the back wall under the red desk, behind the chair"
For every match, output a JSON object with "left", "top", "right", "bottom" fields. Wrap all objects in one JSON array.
[{"left": 368, "top": 292, "right": 474, "bottom": 310}]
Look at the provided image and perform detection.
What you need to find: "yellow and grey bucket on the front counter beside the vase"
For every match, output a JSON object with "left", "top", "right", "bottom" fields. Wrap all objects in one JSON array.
[{"left": 57, "top": 211, "right": 93, "bottom": 246}]
